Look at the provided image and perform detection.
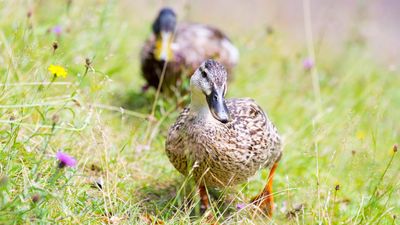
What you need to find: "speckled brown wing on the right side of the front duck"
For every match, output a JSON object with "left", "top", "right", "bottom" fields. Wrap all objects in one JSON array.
[{"left": 226, "top": 98, "right": 282, "bottom": 167}]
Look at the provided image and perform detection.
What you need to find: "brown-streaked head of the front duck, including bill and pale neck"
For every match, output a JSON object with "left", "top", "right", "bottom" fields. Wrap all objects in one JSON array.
[{"left": 190, "top": 59, "right": 231, "bottom": 123}]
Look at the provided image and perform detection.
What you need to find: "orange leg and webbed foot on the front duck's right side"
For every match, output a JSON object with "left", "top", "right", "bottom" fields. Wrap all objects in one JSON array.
[{"left": 251, "top": 163, "right": 278, "bottom": 217}]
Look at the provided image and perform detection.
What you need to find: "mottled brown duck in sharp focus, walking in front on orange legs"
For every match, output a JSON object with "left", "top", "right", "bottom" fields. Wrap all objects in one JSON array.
[{"left": 165, "top": 59, "right": 282, "bottom": 216}]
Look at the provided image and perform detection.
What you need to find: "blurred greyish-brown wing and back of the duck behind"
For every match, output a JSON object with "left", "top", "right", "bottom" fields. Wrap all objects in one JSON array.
[{"left": 174, "top": 23, "right": 239, "bottom": 74}]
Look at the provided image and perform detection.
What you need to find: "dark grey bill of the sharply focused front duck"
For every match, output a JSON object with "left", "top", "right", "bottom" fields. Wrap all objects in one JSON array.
[{"left": 206, "top": 91, "right": 231, "bottom": 123}]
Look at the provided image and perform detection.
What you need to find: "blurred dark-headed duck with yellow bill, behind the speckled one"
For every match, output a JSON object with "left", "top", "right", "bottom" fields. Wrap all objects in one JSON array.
[{"left": 140, "top": 7, "right": 239, "bottom": 92}]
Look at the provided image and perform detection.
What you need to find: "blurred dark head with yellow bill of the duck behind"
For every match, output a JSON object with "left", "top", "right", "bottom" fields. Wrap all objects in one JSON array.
[{"left": 153, "top": 8, "right": 176, "bottom": 61}]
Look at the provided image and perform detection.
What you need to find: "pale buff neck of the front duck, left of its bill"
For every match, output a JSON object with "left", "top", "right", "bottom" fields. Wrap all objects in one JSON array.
[{"left": 190, "top": 90, "right": 213, "bottom": 120}]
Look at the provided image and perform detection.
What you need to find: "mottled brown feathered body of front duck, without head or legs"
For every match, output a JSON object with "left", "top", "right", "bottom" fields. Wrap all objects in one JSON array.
[{"left": 166, "top": 99, "right": 282, "bottom": 187}]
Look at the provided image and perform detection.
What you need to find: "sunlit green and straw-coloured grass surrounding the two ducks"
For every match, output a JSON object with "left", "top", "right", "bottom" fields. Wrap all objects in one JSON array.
[{"left": 0, "top": 0, "right": 400, "bottom": 224}]
